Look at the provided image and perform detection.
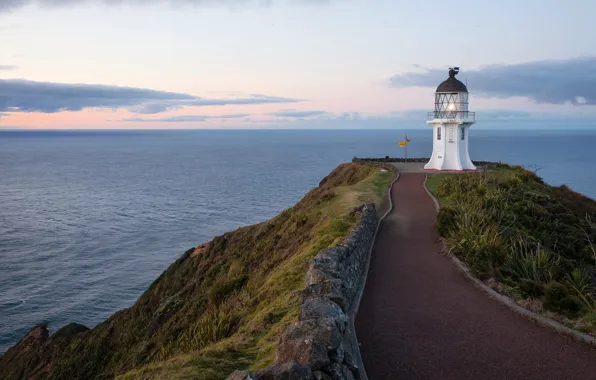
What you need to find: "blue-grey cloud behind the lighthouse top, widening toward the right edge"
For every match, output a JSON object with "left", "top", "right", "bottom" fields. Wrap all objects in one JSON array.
[{"left": 389, "top": 57, "right": 596, "bottom": 105}]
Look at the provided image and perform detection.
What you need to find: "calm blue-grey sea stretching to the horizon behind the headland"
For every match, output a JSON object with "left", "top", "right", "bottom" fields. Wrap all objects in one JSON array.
[{"left": 0, "top": 129, "right": 596, "bottom": 353}]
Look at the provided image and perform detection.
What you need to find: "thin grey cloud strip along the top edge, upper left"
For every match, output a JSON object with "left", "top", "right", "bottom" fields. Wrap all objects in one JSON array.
[{"left": 0, "top": 0, "right": 330, "bottom": 12}]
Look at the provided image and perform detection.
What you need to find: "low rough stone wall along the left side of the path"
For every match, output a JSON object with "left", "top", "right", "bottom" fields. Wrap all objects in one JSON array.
[{"left": 228, "top": 204, "right": 379, "bottom": 380}]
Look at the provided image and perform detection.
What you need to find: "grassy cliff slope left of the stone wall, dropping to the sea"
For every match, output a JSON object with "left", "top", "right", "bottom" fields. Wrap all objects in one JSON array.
[{"left": 0, "top": 164, "right": 392, "bottom": 380}]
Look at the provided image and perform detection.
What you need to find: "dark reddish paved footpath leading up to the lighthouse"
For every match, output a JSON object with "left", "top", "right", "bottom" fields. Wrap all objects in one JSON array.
[{"left": 356, "top": 173, "right": 596, "bottom": 380}]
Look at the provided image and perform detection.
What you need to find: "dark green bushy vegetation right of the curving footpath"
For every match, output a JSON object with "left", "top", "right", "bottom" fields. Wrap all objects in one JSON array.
[{"left": 427, "top": 165, "right": 596, "bottom": 333}]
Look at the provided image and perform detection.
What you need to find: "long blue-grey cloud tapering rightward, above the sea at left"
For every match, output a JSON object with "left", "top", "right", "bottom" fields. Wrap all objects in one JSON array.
[{"left": 0, "top": 79, "right": 300, "bottom": 114}]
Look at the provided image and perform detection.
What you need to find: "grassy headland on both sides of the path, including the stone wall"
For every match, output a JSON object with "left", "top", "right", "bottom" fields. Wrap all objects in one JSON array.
[{"left": 0, "top": 158, "right": 596, "bottom": 380}]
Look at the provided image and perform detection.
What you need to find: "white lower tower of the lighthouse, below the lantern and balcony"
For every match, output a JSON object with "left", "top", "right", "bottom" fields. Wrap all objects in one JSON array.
[{"left": 424, "top": 119, "right": 476, "bottom": 171}]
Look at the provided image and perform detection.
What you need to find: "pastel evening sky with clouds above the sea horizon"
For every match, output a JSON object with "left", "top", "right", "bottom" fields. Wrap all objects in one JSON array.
[{"left": 0, "top": 0, "right": 596, "bottom": 129}]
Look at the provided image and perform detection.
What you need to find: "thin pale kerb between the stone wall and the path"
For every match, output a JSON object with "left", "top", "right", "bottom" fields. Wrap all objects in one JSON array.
[{"left": 348, "top": 172, "right": 400, "bottom": 380}]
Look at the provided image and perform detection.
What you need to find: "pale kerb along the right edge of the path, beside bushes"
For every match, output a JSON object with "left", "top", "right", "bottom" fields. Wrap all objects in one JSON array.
[{"left": 420, "top": 174, "right": 596, "bottom": 348}]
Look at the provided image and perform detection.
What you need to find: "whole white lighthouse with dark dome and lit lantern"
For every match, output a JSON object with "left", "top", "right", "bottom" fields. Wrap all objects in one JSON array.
[{"left": 424, "top": 67, "right": 476, "bottom": 171}]
